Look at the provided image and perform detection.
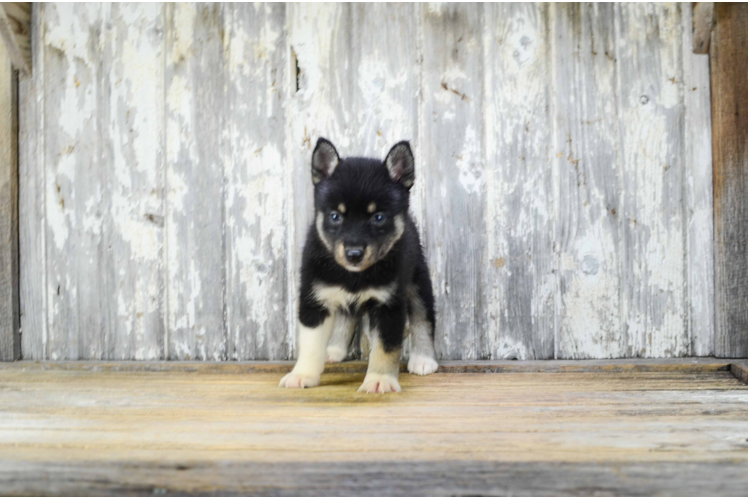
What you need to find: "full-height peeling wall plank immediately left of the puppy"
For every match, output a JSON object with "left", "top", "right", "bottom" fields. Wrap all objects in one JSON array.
[{"left": 224, "top": 3, "right": 288, "bottom": 359}]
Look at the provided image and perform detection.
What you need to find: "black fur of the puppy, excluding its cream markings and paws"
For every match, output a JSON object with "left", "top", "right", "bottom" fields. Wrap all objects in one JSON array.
[{"left": 299, "top": 139, "right": 435, "bottom": 352}]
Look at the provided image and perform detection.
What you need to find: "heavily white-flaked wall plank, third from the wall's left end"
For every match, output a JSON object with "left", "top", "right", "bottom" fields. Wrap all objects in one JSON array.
[{"left": 100, "top": 2, "right": 165, "bottom": 359}]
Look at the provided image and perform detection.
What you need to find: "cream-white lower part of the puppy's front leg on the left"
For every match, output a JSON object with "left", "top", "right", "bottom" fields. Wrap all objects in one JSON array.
[{"left": 279, "top": 314, "right": 335, "bottom": 389}]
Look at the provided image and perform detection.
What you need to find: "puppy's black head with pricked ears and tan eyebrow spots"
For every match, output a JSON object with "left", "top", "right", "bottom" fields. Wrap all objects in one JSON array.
[{"left": 312, "top": 138, "right": 415, "bottom": 272}]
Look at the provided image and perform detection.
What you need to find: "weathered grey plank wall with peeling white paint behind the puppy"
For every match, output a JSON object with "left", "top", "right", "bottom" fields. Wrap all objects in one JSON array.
[{"left": 20, "top": 3, "right": 715, "bottom": 360}]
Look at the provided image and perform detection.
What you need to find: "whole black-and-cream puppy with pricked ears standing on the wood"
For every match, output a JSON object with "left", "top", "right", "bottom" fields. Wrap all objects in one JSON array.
[{"left": 280, "top": 138, "right": 439, "bottom": 393}]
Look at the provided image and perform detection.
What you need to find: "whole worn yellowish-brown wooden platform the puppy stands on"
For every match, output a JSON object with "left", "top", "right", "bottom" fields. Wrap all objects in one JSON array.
[{"left": 0, "top": 359, "right": 748, "bottom": 496}]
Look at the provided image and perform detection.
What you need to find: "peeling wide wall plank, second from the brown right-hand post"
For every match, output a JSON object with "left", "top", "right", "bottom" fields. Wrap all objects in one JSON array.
[{"left": 616, "top": 3, "right": 690, "bottom": 357}]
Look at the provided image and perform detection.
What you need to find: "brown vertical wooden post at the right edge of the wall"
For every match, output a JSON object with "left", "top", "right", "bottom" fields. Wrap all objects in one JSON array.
[{"left": 710, "top": 2, "right": 748, "bottom": 357}]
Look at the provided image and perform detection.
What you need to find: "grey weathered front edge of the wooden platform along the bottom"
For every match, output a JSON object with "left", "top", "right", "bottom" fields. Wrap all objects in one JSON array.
[{"left": 5, "top": 460, "right": 748, "bottom": 497}]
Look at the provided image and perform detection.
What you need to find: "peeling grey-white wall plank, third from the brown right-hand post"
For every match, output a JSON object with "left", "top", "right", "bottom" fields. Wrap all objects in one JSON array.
[{"left": 549, "top": 2, "right": 626, "bottom": 359}]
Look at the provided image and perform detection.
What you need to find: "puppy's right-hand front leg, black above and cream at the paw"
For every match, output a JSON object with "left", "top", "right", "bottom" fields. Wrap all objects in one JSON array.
[{"left": 358, "top": 303, "right": 405, "bottom": 394}]
